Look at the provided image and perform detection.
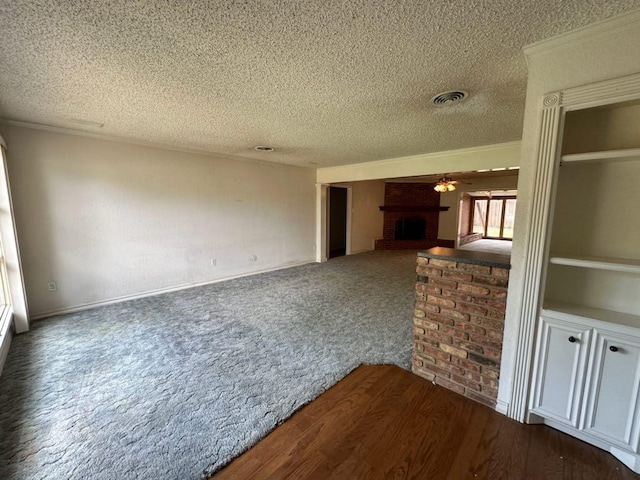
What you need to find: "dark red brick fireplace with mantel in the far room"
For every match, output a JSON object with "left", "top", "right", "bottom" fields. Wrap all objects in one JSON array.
[{"left": 376, "top": 182, "right": 453, "bottom": 250}]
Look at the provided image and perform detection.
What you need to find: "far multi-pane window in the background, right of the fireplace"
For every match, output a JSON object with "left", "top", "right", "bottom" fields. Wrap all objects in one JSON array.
[{"left": 471, "top": 196, "right": 516, "bottom": 240}]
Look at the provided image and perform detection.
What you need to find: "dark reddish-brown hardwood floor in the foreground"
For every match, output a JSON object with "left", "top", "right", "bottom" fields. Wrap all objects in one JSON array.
[{"left": 211, "top": 366, "right": 640, "bottom": 480}]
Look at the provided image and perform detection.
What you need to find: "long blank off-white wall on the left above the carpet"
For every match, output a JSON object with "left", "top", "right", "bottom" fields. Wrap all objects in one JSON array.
[{"left": 0, "top": 125, "right": 315, "bottom": 317}]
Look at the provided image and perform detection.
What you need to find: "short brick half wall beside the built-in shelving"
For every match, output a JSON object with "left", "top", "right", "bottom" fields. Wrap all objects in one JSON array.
[{"left": 412, "top": 249, "right": 510, "bottom": 408}]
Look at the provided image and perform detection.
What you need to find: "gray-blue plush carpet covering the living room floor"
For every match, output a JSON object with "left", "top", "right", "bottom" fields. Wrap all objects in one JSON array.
[{"left": 0, "top": 252, "right": 415, "bottom": 480}]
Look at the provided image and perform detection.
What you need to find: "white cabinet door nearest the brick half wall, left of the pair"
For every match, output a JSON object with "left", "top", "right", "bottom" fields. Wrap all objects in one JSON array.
[{"left": 532, "top": 317, "right": 591, "bottom": 427}]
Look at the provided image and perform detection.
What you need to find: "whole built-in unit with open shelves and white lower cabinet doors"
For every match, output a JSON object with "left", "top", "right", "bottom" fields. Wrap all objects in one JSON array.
[{"left": 529, "top": 90, "right": 640, "bottom": 472}]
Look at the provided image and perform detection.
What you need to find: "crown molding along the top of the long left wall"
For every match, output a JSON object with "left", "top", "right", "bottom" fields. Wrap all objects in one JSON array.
[{"left": 0, "top": 118, "right": 315, "bottom": 169}]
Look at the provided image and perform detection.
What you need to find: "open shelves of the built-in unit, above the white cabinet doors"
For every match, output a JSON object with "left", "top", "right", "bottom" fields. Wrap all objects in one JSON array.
[{"left": 543, "top": 100, "right": 640, "bottom": 318}]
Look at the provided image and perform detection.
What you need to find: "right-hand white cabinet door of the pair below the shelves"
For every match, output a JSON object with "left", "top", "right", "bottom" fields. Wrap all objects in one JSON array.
[{"left": 581, "top": 331, "right": 640, "bottom": 452}]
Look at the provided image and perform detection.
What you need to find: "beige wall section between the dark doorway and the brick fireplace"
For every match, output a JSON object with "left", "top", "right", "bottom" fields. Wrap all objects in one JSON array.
[{"left": 339, "top": 180, "right": 384, "bottom": 254}]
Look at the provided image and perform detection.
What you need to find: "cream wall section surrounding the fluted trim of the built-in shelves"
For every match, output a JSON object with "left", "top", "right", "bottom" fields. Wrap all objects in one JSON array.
[{"left": 498, "top": 10, "right": 640, "bottom": 418}]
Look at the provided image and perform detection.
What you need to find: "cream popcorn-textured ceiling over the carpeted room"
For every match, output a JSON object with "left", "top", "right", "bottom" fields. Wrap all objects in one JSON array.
[{"left": 0, "top": 0, "right": 640, "bottom": 167}]
